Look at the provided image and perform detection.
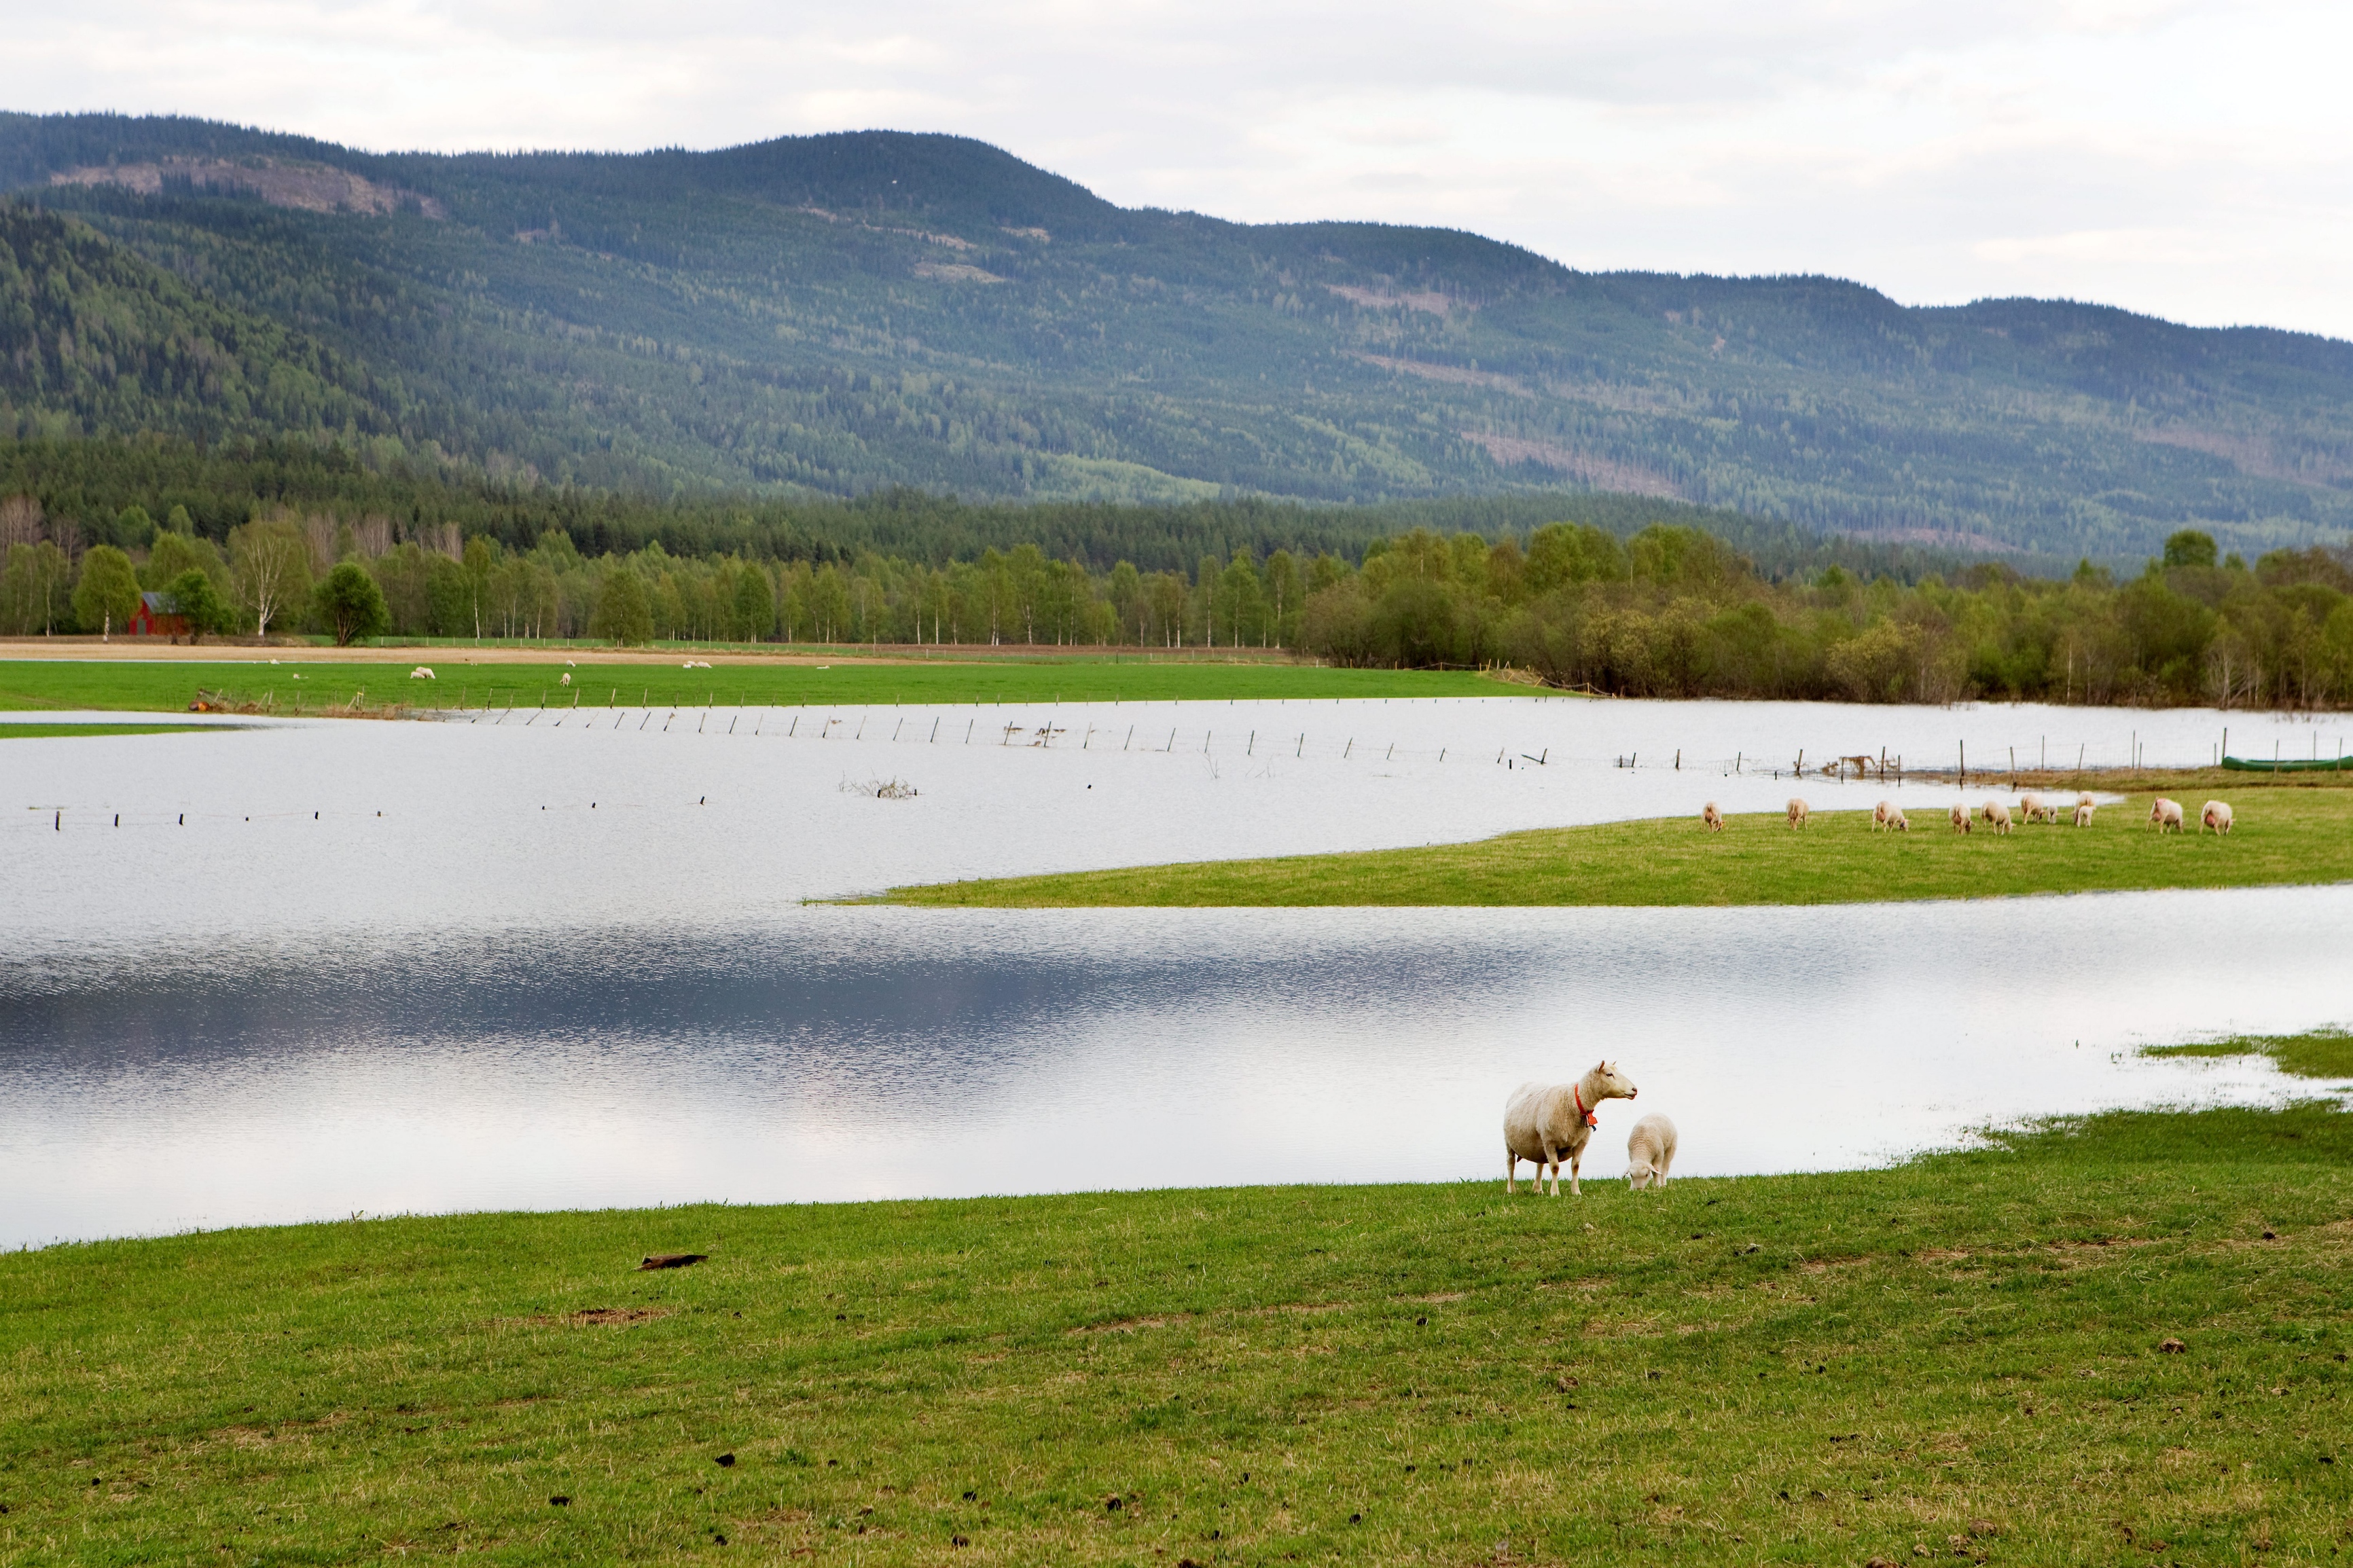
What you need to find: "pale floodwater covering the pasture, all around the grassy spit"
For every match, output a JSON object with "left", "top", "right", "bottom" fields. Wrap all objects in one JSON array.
[{"left": 0, "top": 698, "right": 2353, "bottom": 1246}]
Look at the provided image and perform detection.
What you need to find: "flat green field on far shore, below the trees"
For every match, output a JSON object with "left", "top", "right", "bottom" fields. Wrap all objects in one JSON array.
[{"left": 0, "top": 656, "right": 1541, "bottom": 712}]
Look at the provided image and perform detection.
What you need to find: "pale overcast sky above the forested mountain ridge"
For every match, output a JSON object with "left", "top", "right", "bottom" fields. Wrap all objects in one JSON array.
[{"left": 18, "top": 0, "right": 2353, "bottom": 336}]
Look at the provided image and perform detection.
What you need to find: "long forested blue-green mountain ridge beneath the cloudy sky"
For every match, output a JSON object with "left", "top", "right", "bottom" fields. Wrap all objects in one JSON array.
[{"left": 0, "top": 115, "right": 2353, "bottom": 560}]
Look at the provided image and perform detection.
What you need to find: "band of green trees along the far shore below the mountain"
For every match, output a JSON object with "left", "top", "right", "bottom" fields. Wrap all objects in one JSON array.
[{"left": 0, "top": 484, "right": 2353, "bottom": 708}]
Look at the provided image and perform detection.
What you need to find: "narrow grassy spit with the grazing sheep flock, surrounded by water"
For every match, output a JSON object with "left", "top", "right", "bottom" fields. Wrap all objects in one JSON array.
[{"left": 876, "top": 773, "right": 2353, "bottom": 910}]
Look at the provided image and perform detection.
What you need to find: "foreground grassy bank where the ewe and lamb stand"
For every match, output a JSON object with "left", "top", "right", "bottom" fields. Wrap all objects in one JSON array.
[{"left": 0, "top": 1107, "right": 2353, "bottom": 1568}]
